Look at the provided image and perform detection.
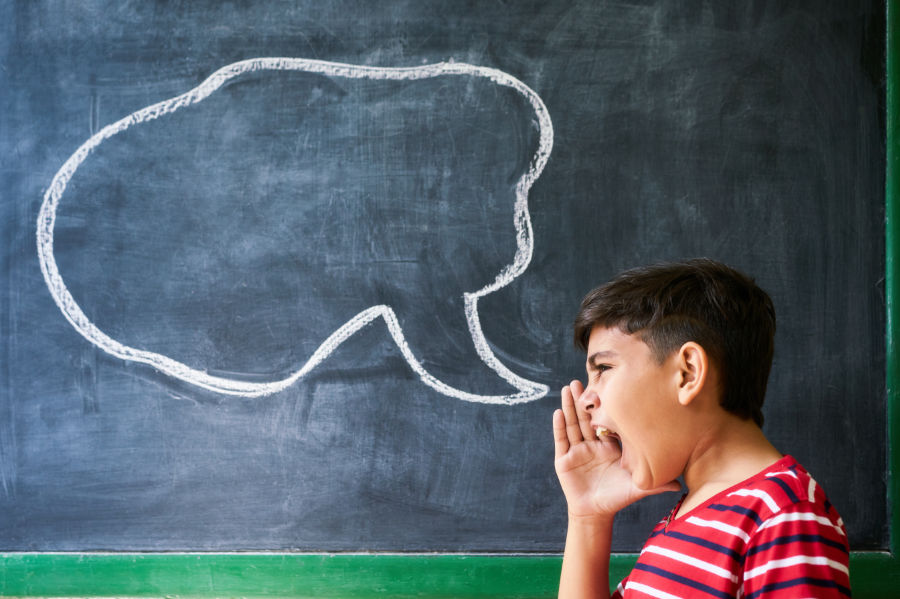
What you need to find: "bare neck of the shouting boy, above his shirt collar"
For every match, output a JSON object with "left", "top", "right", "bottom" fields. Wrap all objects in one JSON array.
[{"left": 678, "top": 414, "right": 783, "bottom": 516}]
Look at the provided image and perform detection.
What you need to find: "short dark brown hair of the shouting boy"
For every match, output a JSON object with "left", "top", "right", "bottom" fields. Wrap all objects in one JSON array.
[{"left": 575, "top": 259, "right": 775, "bottom": 426}]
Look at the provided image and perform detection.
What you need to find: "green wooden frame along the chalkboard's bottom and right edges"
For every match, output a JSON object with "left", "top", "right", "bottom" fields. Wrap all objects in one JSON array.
[{"left": 0, "top": 0, "right": 900, "bottom": 599}]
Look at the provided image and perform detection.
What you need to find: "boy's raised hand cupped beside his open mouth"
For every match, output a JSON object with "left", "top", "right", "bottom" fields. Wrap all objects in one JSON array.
[{"left": 553, "top": 381, "right": 680, "bottom": 518}]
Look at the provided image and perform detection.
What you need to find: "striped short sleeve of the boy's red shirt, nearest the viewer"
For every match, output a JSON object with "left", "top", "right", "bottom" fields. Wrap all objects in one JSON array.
[{"left": 742, "top": 502, "right": 850, "bottom": 599}]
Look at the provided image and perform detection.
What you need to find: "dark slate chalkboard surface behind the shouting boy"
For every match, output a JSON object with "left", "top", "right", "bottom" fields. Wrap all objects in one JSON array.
[{"left": 0, "top": 0, "right": 888, "bottom": 553}]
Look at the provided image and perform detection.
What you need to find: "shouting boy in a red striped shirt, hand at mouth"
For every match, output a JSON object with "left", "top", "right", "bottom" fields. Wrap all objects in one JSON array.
[{"left": 553, "top": 259, "right": 850, "bottom": 599}]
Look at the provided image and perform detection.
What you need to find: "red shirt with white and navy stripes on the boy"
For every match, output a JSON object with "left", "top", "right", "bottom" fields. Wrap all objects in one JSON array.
[{"left": 613, "top": 456, "right": 850, "bottom": 599}]
